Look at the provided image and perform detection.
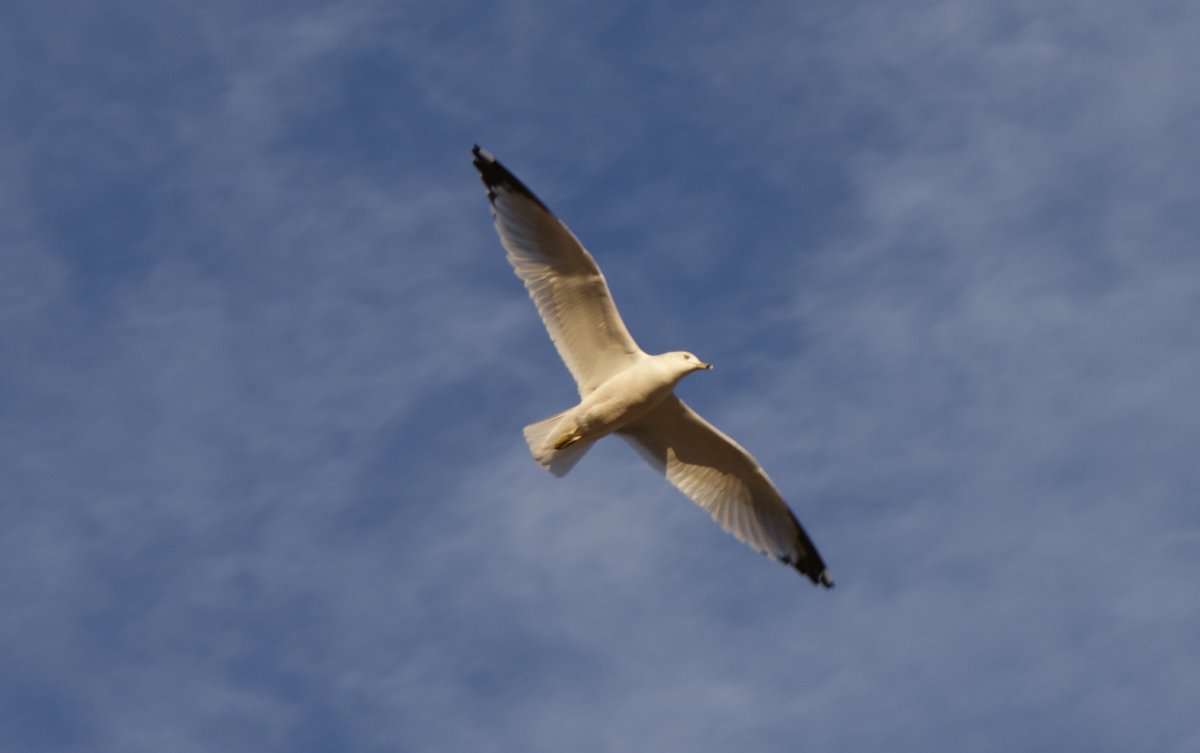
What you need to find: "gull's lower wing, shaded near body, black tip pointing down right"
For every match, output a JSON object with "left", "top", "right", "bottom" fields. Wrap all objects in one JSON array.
[{"left": 618, "top": 394, "right": 833, "bottom": 588}]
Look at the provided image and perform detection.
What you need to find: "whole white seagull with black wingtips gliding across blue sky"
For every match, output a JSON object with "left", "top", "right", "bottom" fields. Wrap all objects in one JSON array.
[{"left": 472, "top": 145, "right": 833, "bottom": 589}]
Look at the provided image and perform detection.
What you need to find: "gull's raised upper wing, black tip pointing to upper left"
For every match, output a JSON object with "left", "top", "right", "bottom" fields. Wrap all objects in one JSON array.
[{"left": 472, "top": 146, "right": 642, "bottom": 397}]
